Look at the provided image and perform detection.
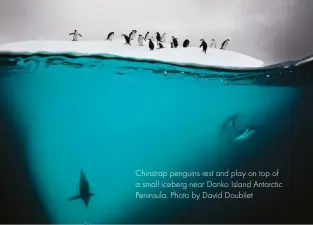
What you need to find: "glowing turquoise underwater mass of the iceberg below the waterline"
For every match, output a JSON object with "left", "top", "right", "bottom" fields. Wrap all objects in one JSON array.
[{"left": 0, "top": 56, "right": 297, "bottom": 224}]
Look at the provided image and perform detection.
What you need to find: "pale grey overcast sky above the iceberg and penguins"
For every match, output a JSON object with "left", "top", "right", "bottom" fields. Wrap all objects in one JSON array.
[{"left": 0, "top": 0, "right": 313, "bottom": 64}]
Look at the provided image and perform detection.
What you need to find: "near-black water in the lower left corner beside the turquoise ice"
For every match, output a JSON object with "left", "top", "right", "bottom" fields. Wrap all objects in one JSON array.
[{"left": 0, "top": 96, "right": 51, "bottom": 224}]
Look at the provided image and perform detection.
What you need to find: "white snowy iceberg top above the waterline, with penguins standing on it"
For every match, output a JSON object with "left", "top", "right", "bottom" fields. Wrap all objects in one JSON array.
[{"left": 0, "top": 39, "right": 264, "bottom": 68}]
